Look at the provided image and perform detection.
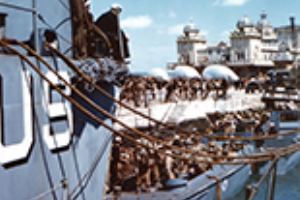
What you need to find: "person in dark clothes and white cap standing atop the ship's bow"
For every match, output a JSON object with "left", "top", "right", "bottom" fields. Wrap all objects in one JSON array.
[{"left": 95, "top": 4, "right": 129, "bottom": 62}]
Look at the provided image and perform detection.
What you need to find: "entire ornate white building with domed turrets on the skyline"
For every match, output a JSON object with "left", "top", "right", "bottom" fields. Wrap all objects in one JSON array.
[{"left": 173, "top": 12, "right": 300, "bottom": 74}]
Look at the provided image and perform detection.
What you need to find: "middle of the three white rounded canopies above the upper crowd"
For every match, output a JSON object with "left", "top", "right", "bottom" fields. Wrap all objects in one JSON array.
[{"left": 168, "top": 66, "right": 201, "bottom": 78}]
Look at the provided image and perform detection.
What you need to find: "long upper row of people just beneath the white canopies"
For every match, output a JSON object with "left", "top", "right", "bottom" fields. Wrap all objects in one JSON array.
[{"left": 119, "top": 70, "right": 291, "bottom": 107}]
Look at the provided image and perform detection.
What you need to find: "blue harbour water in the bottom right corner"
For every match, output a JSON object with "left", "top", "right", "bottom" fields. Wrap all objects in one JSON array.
[{"left": 234, "top": 165, "right": 300, "bottom": 200}]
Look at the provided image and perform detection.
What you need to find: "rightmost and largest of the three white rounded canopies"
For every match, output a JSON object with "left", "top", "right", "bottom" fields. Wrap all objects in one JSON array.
[{"left": 202, "top": 65, "right": 239, "bottom": 81}]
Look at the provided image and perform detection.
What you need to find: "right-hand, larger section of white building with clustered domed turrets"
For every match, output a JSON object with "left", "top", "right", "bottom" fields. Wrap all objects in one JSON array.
[{"left": 228, "top": 13, "right": 300, "bottom": 74}]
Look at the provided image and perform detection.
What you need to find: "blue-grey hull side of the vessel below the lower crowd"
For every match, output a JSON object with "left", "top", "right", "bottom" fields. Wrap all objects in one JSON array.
[{"left": 106, "top": 165, "right": 251, "bottom": 200}]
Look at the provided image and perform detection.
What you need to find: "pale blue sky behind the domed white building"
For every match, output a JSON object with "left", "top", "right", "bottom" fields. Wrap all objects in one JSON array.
[{"left": 92, "top": 0, "right": 300, "bottom": 71}]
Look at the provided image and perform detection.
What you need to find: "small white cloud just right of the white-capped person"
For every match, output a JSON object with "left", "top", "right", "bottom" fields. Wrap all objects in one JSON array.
[{"left": 121, "top": 15, "right": 153, "bottom": 29}]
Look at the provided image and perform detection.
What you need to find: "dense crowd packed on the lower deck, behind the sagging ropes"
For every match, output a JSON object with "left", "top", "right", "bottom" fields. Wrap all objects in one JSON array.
[{"left": 106, "top": 109, "right": 275, "bottom": 195}]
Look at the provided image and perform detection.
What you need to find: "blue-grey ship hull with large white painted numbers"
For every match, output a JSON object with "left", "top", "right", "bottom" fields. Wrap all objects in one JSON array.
[{"left": 0, "top": 56, "right": 114, "bottom": 200}]
